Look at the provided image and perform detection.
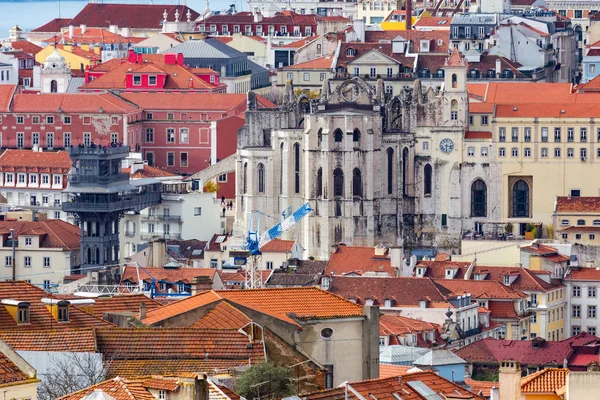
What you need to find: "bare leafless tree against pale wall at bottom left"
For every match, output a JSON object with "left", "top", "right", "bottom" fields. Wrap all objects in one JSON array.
[{"left": 37, "top": 353, "right": 106, "bottom": 400}]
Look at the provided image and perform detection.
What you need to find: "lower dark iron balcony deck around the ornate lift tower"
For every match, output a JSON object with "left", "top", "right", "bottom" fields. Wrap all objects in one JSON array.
[{"left": 62, "top": 192, "right": 161, "bottom": 213}]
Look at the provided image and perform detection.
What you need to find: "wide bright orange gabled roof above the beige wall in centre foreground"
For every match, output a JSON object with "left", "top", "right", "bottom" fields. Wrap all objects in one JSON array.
[{"left": 142, "top": 287, "right": 363, "bottom": 326}]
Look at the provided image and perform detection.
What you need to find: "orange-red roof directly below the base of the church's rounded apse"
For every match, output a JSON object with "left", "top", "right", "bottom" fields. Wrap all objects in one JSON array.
[{"left": 325, "top": 245, "right": 395, "bottom": 276}]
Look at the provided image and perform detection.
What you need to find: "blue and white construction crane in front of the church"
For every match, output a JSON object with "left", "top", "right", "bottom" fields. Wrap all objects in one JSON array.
[{"left": 230, "top": 203, "right": 313, "bottom": 289}]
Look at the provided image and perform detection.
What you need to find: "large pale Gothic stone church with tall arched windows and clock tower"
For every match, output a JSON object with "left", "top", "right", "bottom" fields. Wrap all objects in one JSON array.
[{"left": 236, "top": 52, "right": 501, "bottom": 259}]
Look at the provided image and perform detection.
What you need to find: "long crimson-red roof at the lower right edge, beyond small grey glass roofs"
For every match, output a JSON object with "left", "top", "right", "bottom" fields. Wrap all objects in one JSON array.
[{"left": 455, "top": 332, "right": 599, "bottom": 366}]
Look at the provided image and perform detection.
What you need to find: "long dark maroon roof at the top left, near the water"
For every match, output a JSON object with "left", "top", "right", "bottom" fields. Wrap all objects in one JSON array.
[{"left": 70, "top": 3, "right": 199, "bottom": 29}]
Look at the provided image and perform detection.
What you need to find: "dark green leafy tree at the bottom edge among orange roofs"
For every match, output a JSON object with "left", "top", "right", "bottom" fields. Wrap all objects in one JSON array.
[{"left": 235, "top": 363, "right": 295, "bottom": 400}]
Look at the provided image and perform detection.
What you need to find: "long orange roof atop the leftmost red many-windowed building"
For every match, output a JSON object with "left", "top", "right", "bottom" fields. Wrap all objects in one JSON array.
[{"left": 12, "top": 93, "right": 137, "bottom": 114}]
